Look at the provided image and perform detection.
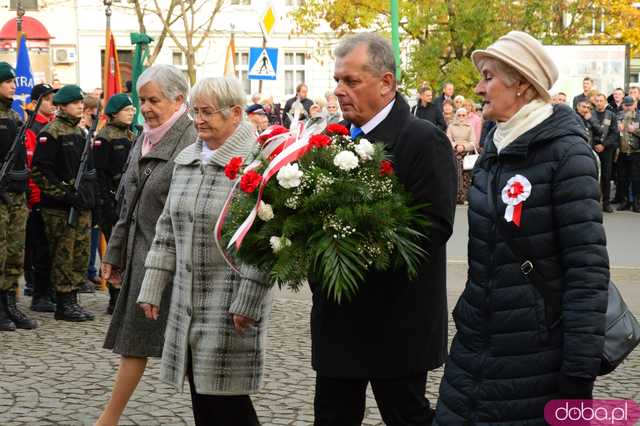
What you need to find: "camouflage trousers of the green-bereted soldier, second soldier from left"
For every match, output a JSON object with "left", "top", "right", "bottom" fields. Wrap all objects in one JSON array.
[{"left": 41, "top": 208, "right": 91, "bottom": 293}]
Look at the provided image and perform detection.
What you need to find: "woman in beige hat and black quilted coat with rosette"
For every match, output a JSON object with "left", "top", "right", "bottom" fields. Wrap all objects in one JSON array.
[{"left": 433, "top": 31, "right": 609, "bottom": 426}]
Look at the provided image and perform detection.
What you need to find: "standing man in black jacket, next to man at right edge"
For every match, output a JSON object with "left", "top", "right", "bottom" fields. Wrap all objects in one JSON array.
[{"left": 590, "top": 93, "right": 620, "bottom": 213}]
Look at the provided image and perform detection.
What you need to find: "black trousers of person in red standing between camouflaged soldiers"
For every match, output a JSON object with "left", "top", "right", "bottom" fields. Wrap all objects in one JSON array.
[{"left": 24, "top": 206, "right": 51, "bottom": 296}]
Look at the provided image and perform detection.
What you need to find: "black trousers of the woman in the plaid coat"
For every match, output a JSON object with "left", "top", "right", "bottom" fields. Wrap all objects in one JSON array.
[{"left": 187, "top": 353, "right": 260, "bottom": 426}]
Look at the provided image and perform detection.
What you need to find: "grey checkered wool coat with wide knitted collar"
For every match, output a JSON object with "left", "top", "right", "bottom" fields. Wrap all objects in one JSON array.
[{"left": 138, "top": 122, "right": 271, "bottom": 395}]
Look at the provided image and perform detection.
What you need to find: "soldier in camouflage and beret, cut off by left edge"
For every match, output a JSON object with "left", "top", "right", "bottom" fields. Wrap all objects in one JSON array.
[{"left": 0, "top": 62, "right": 38, "bottom": 331}]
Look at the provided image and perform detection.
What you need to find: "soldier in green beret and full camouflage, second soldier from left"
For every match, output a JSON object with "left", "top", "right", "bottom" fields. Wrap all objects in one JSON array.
[{"left": 31, "top": 84, "right": 96, "bottom": 321}]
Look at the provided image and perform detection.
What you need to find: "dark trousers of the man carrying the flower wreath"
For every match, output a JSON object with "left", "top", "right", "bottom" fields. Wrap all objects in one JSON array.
[{"left": 314, "top": 373, "right": 434, "bottom": 426}]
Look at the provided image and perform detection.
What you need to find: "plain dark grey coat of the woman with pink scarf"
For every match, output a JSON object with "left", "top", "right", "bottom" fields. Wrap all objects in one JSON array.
[{"left": 104, "top": 113, "right": 197, "bottom": 357}]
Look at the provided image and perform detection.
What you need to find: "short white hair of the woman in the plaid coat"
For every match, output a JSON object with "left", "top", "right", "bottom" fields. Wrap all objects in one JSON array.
[{"left": 191, "top": 77, "right": 246, "bottom": 118}]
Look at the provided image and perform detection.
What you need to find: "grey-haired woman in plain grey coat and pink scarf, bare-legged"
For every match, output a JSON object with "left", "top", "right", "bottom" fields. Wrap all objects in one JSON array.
[{"left": 96, "top": 65, "right": 196, "bottom": 426}]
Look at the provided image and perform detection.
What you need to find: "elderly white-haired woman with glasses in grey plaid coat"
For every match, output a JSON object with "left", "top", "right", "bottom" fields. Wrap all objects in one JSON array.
[{"left": 138, "top": 77, "right": 271, "bottom": 426}]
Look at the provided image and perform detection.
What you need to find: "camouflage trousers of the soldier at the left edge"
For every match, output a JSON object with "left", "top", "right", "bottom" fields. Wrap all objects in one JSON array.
[{"left": 0, "top": 192, "right": 29, "bottom": 291}]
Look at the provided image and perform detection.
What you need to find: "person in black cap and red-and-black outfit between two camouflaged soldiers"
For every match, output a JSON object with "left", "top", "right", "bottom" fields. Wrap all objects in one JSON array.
[{"left": 24, "top": 84, "right": 57, "bottom": 312}]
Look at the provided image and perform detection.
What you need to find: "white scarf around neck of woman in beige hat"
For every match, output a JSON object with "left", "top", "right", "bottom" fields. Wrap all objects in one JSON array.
[{"left": 493, "top": 100, "right": 553, "bottom": 153}]
